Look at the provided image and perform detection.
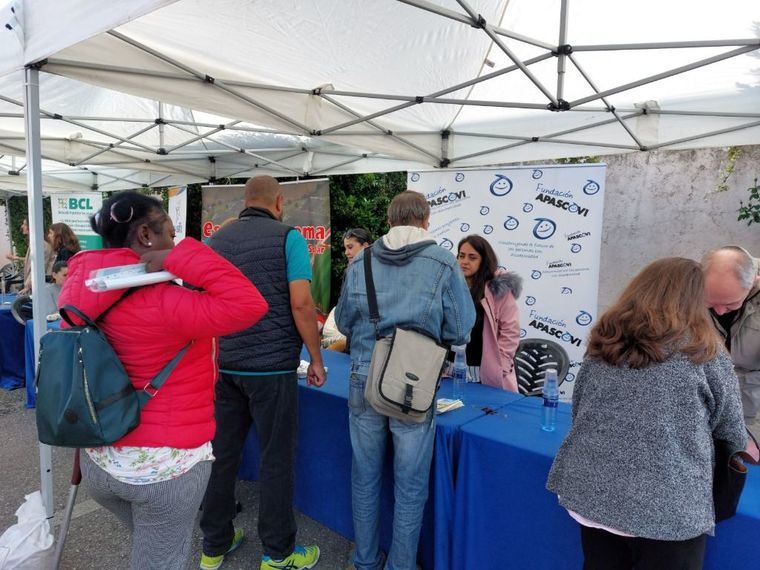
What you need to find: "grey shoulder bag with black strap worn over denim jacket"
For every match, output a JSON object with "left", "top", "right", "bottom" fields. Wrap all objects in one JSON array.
[{"left": 364, "top": 247, "right": 448, "bottom": 423}]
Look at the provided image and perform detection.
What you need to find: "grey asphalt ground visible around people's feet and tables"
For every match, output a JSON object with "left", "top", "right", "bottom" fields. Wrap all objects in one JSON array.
[{"left": 0, "top": 390, "right": 352, "bottom": 570}]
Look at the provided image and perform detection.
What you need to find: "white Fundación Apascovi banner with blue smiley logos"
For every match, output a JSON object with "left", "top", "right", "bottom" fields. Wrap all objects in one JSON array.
[{"left": 408, "top": 164, "right": 606, "bottom": 400}]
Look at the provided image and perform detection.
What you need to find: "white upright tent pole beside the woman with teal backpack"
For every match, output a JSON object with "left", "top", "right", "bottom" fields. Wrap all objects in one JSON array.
[{"left": 24, "top": 67, "right": 54, "bottom": 518}]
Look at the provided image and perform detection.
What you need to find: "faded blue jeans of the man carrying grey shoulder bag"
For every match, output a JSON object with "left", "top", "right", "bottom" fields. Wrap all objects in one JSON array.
[{"left": 348, "top": 373, "right": 435, "bottom": 570}]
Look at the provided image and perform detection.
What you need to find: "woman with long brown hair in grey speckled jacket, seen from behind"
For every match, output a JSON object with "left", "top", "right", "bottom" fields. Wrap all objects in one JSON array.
[{"left": 547, "top": 257, "right": 747, "bottom": 570}]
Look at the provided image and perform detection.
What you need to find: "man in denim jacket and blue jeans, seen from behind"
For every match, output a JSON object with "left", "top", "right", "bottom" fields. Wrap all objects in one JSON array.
[{"left": 335, "top": 192, "right": 475, "bottom": 570}]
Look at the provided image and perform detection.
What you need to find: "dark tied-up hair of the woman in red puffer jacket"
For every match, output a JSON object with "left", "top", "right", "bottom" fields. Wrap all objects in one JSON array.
[{"left": 90, "top": 191, "right": 166, "bottom": 247}]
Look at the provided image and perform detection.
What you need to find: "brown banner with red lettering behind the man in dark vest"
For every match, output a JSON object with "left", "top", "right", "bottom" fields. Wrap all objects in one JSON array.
[{"left": 201, "top": 178, "right": 332, "bottom": 314}]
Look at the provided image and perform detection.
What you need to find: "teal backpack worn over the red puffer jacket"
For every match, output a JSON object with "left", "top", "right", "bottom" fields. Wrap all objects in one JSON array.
[{"left": 35, "top": 289, "right": 190, "bottom": 447}]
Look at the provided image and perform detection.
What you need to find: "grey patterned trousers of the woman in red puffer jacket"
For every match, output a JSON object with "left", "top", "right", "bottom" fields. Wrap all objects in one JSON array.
[{"left": 81, "top": 450, "right": 211, "bottom": 570}]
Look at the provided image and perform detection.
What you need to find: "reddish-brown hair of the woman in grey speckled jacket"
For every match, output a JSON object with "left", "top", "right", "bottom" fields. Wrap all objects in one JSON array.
[{"left": 586, "top": 257, "right": 721, "bottom": 368}]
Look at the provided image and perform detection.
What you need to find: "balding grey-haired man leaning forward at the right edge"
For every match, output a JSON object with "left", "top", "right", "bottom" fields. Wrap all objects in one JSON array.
[{"left": 702, "top": 245, "right": 760, "bottom": 425}]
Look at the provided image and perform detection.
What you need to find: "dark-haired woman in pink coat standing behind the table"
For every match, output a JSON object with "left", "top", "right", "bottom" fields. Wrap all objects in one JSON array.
[{"left": 457, "top": 235, "right": 522, "bottom": 392}]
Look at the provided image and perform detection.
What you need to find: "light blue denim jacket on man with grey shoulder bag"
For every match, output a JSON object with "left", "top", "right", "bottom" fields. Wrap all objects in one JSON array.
[{"left": 335, "top": 228, "right": 475, "bottom": 375}]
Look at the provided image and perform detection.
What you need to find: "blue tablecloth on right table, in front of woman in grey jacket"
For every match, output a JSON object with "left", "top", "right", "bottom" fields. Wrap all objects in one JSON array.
[{"left": 451, "top": 398, "right": 760, "bottom": 570}]
